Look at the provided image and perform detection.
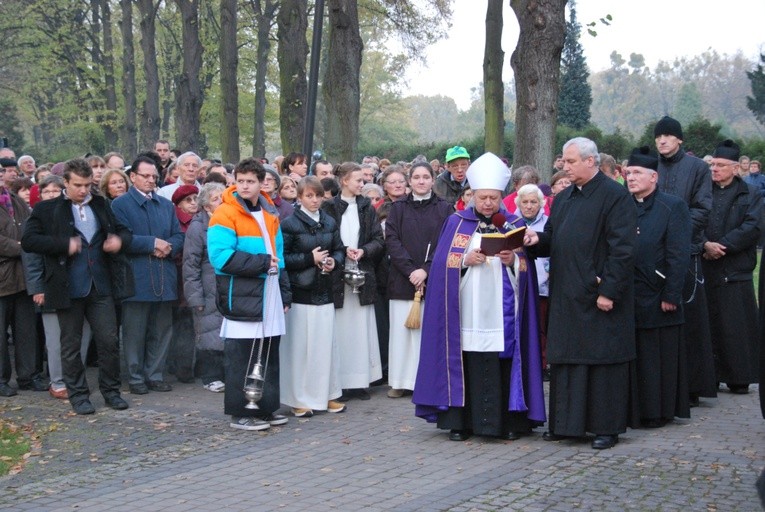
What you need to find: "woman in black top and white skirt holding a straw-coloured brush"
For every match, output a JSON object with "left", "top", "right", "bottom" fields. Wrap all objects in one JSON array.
[{"left": 385, "top": 162, "right": 453, "bottom": 398}]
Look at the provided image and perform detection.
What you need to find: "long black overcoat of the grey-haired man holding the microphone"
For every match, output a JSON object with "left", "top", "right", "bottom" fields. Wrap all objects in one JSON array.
[{"left": 532, "top": 172, "right": 637, "bottom": 365}]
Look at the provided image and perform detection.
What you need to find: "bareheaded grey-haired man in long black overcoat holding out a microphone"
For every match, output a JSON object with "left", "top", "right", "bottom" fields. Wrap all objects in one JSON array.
[{"left": 525, "top": 137, "right": 637, "bottom": 449}]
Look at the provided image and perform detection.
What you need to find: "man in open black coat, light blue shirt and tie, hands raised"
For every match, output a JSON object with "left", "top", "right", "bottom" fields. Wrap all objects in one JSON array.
[{"left": 21, "top": 159, "right": 132, "bottom": 414}]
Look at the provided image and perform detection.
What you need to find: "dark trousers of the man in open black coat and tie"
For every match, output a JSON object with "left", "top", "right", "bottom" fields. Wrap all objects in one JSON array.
[{"left": 56, "top": 288, "right": 120, "bottom": 405}]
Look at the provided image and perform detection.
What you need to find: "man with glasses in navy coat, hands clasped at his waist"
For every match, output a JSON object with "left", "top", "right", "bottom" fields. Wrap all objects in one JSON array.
[{"left": 112, "top": 156, "right": 183, "bottom": 395}]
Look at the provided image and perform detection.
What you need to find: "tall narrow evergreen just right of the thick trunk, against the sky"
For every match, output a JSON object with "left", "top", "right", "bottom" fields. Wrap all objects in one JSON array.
[{"left": 558, "top": 0, "right": 592, "bottom": 129}]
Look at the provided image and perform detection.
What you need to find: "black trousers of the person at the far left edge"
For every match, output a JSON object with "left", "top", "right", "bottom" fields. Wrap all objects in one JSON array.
[{"left": 0, "top": 291, "right": 42, "bottom": 386}]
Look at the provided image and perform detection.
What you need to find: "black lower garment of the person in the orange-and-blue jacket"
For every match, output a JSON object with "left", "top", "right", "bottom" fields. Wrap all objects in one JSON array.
[{"left": 223, "top": 336, "right": 281, "bottom": 418}]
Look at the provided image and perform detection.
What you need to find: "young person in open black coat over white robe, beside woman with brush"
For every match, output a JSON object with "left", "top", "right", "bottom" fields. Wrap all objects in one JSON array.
[{"left": 322, "top": 162, "right": 383, "bottom": 400}]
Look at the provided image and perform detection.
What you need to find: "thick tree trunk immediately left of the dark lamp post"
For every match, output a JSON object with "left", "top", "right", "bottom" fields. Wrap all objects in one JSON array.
[{"left": 276, "top": 0, "right": 308, "bottom": 154}]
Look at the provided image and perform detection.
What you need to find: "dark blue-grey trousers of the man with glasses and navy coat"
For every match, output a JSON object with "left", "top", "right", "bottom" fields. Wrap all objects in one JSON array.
[{"left": 122, "top": 301, "right": 173, "bottom": 385}]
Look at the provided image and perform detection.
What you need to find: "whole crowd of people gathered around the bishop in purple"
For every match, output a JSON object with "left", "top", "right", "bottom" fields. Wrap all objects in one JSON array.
[{"left": 0, "top": 117, "right": 765, "bottom": 449}]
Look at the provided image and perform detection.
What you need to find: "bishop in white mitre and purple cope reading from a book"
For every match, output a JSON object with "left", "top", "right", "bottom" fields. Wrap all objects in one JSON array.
[{"left": 412, "top": 153, "right": 546, "bottom": 441}]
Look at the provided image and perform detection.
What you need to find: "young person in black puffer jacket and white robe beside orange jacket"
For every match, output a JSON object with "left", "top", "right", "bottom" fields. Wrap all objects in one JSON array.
[{"left": 279, "top": 176, "right": 345, "bottom": 417}]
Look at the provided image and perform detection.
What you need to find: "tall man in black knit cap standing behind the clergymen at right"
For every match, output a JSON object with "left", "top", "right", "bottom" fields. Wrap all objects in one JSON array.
[{"left": 653, "top": 116, "right": 717, "bottom": 407}]
